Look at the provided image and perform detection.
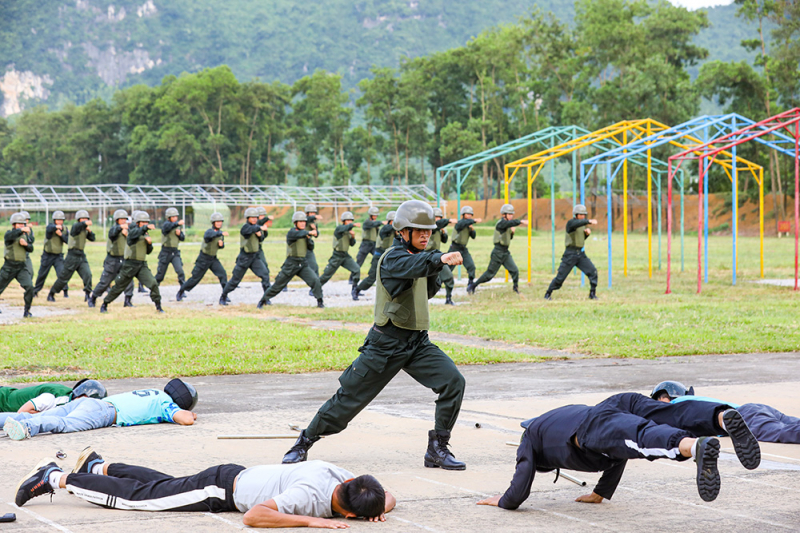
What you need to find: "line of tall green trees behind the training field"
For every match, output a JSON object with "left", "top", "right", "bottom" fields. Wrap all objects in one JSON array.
[{"left": 0, "top": 0, "right": 800, "bottom": 216}]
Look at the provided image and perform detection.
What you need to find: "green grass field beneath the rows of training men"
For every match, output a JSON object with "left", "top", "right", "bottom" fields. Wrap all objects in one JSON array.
[{"left": 0, "top": 224, "right": 800, "bottom": 379}]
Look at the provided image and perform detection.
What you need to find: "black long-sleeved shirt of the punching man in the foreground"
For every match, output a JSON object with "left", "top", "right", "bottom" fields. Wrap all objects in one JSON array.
[{"left": 381, "top": 237, "right": 445, "bottom": 298}]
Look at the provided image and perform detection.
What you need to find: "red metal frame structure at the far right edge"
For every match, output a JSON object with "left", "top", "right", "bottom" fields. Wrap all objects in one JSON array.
[{"left": 667, "top": 108, "right": 800, "bottom": 294}]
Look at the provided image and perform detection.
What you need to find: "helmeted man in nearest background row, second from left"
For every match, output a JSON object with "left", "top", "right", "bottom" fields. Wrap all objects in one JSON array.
[{"left": 100, "top": 211, "right": 164, "bottom": 313}]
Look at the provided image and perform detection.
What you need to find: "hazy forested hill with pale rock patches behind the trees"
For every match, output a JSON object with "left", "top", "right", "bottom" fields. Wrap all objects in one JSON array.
[{"left": 0, "top": 0, "right": 746, "bottom": 115}]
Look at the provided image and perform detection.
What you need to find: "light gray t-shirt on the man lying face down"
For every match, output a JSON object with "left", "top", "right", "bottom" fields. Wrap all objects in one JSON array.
[{"left": 233, "top": 461, "right": 355, "bottom": 518}]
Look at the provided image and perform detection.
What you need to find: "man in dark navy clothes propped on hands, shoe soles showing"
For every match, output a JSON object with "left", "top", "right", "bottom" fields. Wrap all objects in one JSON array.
[{"left": 478, "top": 393, "right": 761, "bottom": 509}]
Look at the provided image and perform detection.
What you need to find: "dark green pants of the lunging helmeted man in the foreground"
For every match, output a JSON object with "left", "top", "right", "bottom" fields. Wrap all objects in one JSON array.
[{"left": 306, "top": 326, "right": 465, "bottom": 437}]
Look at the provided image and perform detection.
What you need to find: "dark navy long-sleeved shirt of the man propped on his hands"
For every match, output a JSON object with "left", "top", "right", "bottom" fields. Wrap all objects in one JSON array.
[{"left": 498, "top": 405, "right": 627, "bottom": 509}]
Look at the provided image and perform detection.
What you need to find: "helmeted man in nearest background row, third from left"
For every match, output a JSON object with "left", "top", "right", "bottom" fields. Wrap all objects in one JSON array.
[{"left": 257, "top": 211, "right": 325, "bottom": 309}]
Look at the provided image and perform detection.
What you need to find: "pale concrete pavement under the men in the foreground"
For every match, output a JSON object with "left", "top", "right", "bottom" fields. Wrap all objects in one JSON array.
[{"left": 0, "top": 353, "right": 800, "bottom": 533}]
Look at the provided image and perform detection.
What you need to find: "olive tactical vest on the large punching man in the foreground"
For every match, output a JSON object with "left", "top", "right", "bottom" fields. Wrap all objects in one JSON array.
[{"left": 375, "top": 248, "right": 430, "bottom": 331}]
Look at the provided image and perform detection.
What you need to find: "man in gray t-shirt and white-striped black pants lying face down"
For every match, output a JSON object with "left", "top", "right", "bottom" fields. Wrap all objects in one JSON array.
[{"left": 15, "top": 447, "right": 396, "bottom": 529}]
